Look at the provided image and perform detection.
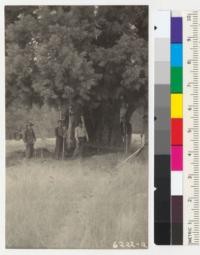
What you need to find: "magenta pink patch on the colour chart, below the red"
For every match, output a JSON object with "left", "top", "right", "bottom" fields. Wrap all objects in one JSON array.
[{"left": 171, "top": 146, "right": 183, "bottom": 171}]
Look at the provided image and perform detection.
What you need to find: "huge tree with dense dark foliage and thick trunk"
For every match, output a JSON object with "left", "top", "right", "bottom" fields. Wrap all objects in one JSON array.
[{"left": 6, "top": 6, "right": 148, "bottom": 143}]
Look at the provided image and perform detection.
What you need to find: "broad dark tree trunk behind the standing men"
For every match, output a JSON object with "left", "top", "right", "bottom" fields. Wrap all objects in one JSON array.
[{"left": 65, "top": 99, "right": 128, "bottom": 149}]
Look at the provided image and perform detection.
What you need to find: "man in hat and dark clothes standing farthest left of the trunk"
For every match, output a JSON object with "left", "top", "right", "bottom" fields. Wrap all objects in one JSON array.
[{"left": 23, "top": 122, "right": 36, "bottom": 159}]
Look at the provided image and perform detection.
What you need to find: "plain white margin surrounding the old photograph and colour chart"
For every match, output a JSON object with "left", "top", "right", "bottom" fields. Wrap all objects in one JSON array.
[{"left": 0, "top": 0, "right": 200, "bottom": 255}]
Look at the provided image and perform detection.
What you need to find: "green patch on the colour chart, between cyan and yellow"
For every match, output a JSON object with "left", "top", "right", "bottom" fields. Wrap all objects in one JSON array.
[{"left": 170, "top": 67, "right": 183, "bottom": 93}]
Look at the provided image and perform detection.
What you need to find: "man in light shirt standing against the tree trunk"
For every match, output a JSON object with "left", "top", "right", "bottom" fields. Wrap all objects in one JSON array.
[{"left": 74, "top": 116, "right": 89, "bottom": 156}]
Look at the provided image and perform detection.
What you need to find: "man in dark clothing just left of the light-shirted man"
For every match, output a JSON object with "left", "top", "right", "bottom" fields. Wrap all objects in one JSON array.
[{"left": 55, "top": 120, "right": 64, "bottom": 159}]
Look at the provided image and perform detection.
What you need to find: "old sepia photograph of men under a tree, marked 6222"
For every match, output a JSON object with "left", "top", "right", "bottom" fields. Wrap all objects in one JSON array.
[{"left": 4, "top": 2, "right": 149, "bottom": 249}]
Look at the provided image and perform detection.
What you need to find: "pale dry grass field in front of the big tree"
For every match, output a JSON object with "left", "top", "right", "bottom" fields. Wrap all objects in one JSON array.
[{"left": 6, "top": 140, "right": 148, "bottom": 248}]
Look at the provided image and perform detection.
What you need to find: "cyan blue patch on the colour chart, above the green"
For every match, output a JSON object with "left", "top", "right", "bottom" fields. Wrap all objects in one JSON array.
[{"left": 171, "top": 43, "right": 183, "bottom": 67}]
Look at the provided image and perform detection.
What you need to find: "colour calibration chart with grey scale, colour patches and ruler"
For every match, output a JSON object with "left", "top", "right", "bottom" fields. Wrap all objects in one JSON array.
[{"left": 154, "top": 10, "right": 200, "bottom": 245}]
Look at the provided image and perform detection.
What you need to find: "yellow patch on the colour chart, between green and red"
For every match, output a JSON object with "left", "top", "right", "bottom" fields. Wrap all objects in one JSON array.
[{"left": 171, "top": 94, "right": 183, "bottom": 118}]
